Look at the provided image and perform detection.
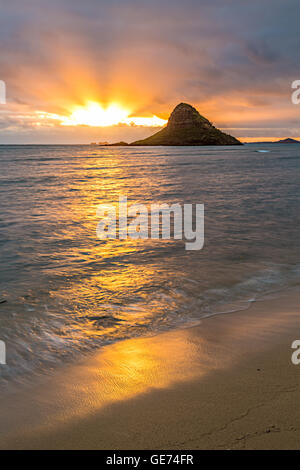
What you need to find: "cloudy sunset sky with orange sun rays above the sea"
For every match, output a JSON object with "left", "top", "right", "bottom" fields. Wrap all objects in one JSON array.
[{"left": 0, "top": 0, "right": 300, "bottom": 144}]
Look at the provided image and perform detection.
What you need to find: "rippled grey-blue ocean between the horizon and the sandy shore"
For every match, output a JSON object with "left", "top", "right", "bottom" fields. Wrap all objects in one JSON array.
[{"left": 0, "top": 144, "right": 300, "bottom": 384}]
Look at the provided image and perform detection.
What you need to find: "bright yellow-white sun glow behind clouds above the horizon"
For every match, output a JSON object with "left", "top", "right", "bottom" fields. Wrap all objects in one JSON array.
[{"left": 49, "top": 102, "right": 167, "bottom": 127}]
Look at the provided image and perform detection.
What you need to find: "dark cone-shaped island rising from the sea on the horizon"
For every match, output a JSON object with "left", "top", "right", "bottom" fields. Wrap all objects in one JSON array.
[{"left": 131, "top": 103, "right": 242, "bottom": 146}]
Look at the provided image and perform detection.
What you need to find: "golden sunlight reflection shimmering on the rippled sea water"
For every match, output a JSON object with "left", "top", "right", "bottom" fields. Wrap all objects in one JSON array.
[{"left": 47, "top": 149, "right": 190, "bottom": 345}]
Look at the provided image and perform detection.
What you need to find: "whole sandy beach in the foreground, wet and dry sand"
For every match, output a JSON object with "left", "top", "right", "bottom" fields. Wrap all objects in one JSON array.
[{"left": 0, "top": 291, "right": 300, "bottom": 450}]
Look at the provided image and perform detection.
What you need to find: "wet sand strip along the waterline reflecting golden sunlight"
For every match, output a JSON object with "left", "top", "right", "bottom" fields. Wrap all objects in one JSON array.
[{"left": 1, "top": 292, "right": 299, "bottom": 446}]
